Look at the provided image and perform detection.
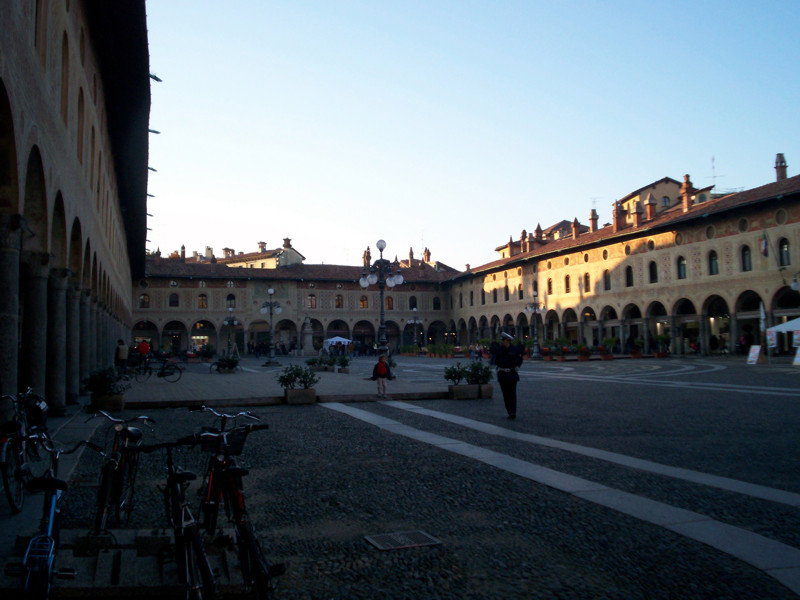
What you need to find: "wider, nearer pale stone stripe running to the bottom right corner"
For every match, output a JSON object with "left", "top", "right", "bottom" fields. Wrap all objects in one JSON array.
[{"left": 322, "top": 403, "right": 800, "bottom": 594}]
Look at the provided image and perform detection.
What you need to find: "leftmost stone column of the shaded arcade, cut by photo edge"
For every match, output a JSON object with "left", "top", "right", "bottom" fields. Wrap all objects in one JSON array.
[{"left": 0, "top": 214, "right": 22, "bottom": 394}]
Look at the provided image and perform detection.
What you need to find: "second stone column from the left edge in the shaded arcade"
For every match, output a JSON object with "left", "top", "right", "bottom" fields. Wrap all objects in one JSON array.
[{"left": 19, "top": 252, "right": 50, "bottom": 396}]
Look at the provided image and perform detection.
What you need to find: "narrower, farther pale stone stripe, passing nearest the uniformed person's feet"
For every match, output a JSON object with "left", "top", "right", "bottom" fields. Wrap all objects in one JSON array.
[{"left": 382, "top": 401, "right": 800, "bottom": 507}]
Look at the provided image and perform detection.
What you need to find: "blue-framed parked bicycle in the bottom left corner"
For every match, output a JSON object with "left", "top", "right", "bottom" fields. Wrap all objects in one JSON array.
[{"left": 6, "top": 432, "right": 103, "bottom": 600}]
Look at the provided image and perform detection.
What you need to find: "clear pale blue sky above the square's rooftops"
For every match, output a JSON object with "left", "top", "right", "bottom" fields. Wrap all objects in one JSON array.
[{"left": 147, "top": 0, "right": 800, "bottom": 269}]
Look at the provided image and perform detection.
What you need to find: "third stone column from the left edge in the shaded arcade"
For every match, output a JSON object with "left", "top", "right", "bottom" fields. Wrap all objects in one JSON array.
[{"left": 45, "top": 269, "right": 70, "bottom": 414}]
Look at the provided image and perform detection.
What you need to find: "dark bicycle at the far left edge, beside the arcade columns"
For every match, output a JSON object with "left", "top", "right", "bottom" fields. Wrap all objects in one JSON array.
[{"left": 0, "top": 388, "right": 47, "bottom": 513}]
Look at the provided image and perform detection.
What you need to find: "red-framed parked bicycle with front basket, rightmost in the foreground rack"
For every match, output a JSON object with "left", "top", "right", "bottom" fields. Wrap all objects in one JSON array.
[{"left": 196, "top": 406, "right": 286, "bottom": 599}]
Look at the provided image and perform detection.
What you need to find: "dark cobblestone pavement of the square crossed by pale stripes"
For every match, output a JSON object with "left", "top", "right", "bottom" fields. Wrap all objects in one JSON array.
[{"left": 0, "top": 357, "right": 800, "bottom": 599}]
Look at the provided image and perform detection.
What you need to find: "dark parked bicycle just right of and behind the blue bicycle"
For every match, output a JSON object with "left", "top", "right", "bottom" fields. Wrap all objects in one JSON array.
[{"left": 87, "top": 410, "right": 155, "bottom": 535}]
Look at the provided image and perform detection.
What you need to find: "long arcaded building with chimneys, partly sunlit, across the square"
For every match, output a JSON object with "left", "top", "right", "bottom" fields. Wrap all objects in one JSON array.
[{"left": 133, "top": 154, "right": 800, "bottom": 354}]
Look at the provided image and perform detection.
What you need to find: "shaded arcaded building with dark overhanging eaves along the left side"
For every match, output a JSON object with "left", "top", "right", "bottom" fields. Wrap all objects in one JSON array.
[{"left": 0, "top": 0, "right": 150, "bottom": 410}]
